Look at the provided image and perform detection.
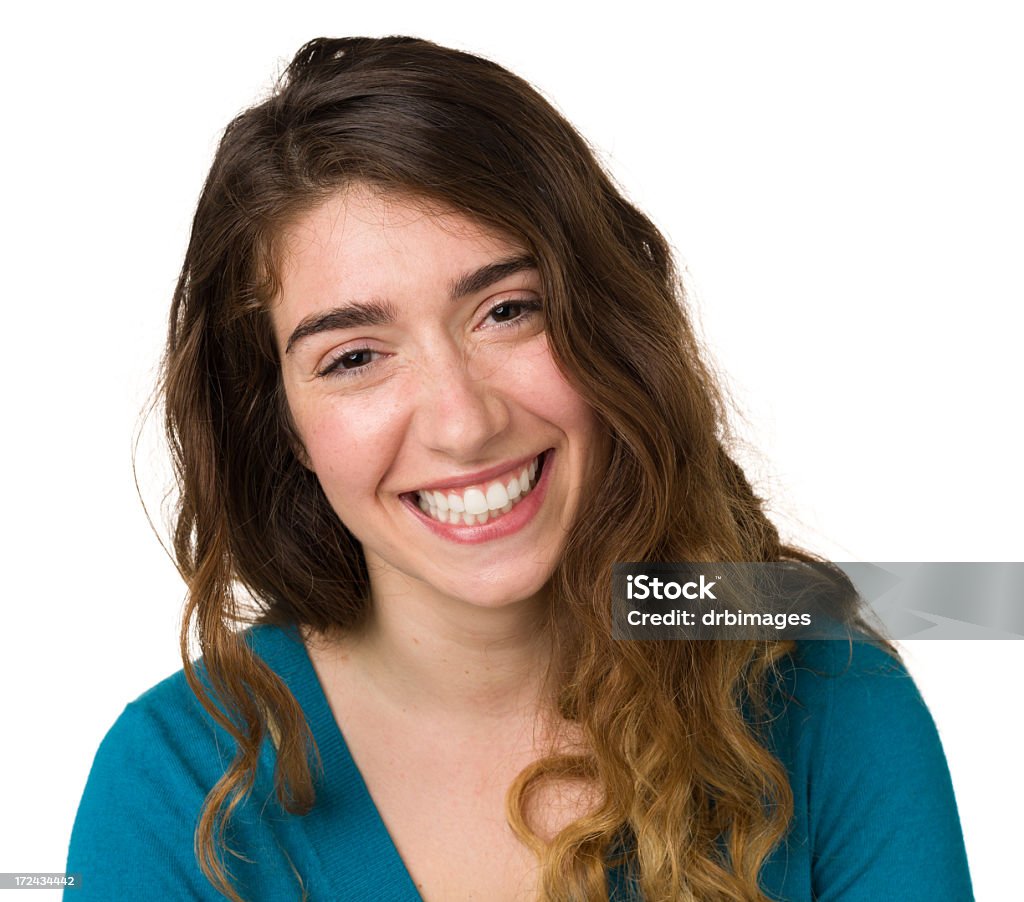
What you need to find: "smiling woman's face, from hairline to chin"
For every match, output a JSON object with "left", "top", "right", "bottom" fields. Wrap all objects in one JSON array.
[{"left": 271, "top": 186, "right": 606, "bottom": 606}]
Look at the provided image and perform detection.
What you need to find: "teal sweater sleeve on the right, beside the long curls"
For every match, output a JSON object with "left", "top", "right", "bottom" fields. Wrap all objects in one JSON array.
[{"left": 802, "top": 642, "right": 974, "bottom": 902}]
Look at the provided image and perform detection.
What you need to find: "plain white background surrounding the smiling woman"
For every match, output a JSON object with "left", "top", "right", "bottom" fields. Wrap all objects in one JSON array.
[{"left": 0, "top": 0, "right": 1024, "bottom": 900}]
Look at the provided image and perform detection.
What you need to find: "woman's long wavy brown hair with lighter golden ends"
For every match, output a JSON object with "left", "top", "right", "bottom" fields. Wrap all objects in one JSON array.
[{"left": 162, "top": 37, "right": 884, "bottom": 902}]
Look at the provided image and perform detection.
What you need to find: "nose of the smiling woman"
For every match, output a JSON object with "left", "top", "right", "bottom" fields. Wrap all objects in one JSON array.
[{"left": 416, "top": 348, "right": 510, "bottom": 462}]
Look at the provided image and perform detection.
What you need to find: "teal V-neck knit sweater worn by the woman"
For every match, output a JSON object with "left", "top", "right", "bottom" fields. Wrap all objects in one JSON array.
[{"left": 68, "top": 627, "right": 974, "bottom": 902}]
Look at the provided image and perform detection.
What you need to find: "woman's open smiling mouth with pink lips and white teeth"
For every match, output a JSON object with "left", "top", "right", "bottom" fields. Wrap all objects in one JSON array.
[{"left": 401, "top": 448, "right": 553, "bottom": 543}]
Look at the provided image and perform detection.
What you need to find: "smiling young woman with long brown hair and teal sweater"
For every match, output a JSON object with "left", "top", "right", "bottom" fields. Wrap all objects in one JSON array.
[{"left": 68, "top": 38, "right": 971, "bottom": 902}]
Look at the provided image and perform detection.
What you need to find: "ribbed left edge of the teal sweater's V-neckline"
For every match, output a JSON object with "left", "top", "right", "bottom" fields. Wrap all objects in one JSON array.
[{"left": 250, "top": 626, "right": 423, "bottom": 902}]
